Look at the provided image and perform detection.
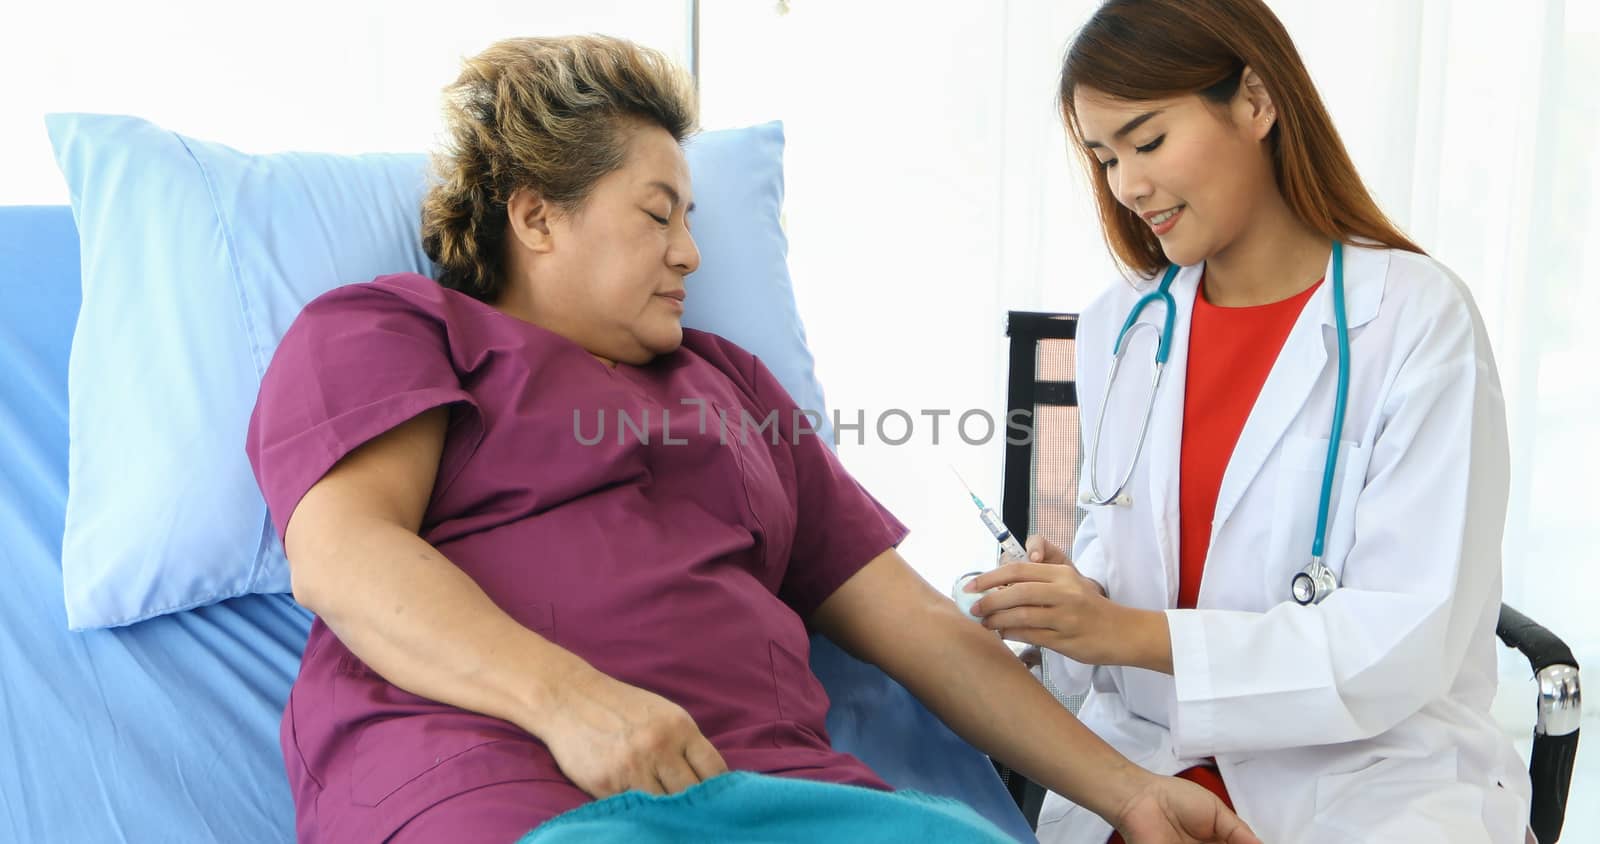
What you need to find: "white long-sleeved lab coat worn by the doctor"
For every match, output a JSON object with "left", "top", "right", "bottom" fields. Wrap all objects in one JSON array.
[{"left": 1038, "top": 245, "right": 1530, "bottom": 844}]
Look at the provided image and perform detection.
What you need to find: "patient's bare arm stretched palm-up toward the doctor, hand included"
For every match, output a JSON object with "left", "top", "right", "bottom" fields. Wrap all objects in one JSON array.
[{"left": 811, "top": 550, "right": 1256, "bottom": 844}]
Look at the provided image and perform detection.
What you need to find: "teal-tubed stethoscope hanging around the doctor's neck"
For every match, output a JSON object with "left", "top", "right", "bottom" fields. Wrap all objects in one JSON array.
[{"left": 1082, "top": 240, "right": 1350, "bottom": 606}]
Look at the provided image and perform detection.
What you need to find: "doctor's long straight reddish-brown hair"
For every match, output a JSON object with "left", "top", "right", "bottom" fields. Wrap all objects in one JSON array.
[{"left": 1061, "top": 0, "right": 1422, "bottom": 275}]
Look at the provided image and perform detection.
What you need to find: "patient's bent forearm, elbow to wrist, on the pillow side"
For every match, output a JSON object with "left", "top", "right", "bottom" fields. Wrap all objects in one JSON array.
[{"left": 296, "top": 520, "right": 594, "bottom": 735}]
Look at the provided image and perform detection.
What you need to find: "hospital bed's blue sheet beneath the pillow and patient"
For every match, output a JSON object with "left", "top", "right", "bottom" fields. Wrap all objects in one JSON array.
[{"left": 0, "top": 206, "right": 1032, "bottom": 844}]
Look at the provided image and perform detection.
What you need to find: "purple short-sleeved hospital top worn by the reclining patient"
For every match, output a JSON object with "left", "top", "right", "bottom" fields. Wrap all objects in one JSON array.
[{"left": 248, "top": 273, "right": 906, "bottom": 844}]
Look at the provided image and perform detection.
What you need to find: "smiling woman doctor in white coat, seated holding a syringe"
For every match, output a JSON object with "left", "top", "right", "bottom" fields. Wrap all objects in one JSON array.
[{"left": 968, "top": 0, "right": 1530, "bottom": 844}]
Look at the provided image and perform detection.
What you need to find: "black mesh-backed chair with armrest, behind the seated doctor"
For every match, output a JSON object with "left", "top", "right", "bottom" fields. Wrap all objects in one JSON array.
[{"left": 997, "top": 312, "right": 1582, "bottom": 844}]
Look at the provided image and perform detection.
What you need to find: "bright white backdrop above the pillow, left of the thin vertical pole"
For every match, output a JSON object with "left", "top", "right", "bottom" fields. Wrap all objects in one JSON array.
[{"left": 0, "top": 0, "right": 690, "bottom": 205}]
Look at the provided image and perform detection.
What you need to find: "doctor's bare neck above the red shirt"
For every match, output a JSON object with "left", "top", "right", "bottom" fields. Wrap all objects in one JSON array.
[{"left": 1205, "top": 190, "right": 1333, "bottom": 307}]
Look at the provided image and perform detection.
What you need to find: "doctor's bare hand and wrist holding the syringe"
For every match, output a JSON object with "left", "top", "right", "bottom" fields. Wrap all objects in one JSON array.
[{"left": 966, "top": 553, "right": 1173, "bottom": 673}]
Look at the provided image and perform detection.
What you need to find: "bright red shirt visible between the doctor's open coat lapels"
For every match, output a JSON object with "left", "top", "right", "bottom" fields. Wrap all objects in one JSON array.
[{"left": 1178, "top": 278, "right": 1322, "bottom": 609}]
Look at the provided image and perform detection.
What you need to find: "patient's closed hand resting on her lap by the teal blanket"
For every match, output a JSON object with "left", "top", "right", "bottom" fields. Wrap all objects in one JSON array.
[{"left": 536, "top": 671, "right": 728, "bottom": 799}]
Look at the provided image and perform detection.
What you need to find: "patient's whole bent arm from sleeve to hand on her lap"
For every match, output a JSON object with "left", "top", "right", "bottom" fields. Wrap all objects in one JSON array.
[{"left": 285, "top": 408, "right": 726, "bottom": 798}]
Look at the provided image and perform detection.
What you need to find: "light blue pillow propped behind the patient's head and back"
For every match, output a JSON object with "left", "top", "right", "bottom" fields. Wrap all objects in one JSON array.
[{"left": 46, "top": 113, "right": 822, "bottom": 630}]
